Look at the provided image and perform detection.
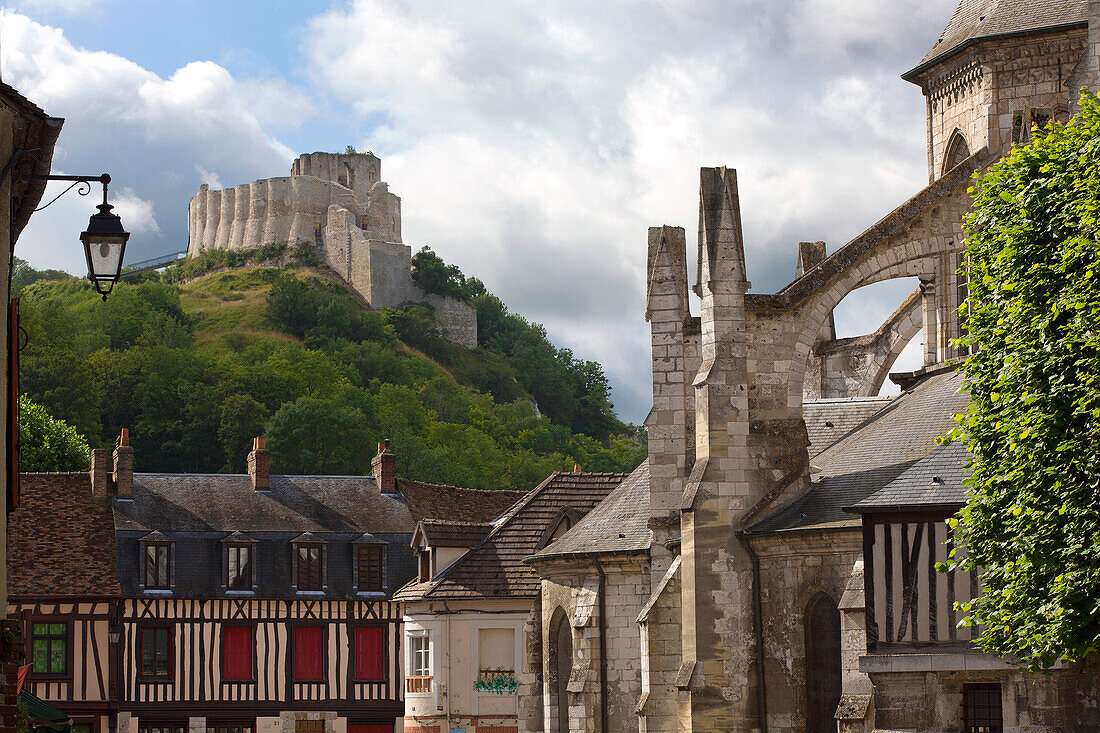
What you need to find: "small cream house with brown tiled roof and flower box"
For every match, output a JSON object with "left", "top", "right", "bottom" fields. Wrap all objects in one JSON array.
[{"left": 395, "top": 471, "right": 624, "bottom": 733}]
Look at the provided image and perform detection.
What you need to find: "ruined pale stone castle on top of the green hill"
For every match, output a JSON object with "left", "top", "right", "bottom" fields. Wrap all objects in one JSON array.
[{"left": 187, "top": 153, "right": 477, "bottom": 349}]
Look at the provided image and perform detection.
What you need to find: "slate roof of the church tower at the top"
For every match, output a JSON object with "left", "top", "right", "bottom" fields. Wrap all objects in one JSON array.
[{"left": 903, "top": 0, "right": 1089, "bottom": 80}]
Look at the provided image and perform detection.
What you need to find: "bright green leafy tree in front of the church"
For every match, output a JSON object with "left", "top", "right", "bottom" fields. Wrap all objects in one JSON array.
[{"left": 955, "top": 92, "right": 1100, "bottom": 668}]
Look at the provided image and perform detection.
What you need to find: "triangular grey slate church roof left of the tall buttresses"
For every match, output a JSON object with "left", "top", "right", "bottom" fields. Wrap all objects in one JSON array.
[{"left": 530, "top": 460, "right": 653, "bottom": 562}]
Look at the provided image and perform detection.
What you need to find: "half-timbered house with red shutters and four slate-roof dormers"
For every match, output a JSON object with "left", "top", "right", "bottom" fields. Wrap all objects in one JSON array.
[{"left": 106, "top": 437, "right": 414, "bottom": 733}]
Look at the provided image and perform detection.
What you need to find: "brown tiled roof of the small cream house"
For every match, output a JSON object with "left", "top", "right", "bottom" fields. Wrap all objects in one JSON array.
[{"left": 394, "top": 471, "right": 626, "bottom": 602}]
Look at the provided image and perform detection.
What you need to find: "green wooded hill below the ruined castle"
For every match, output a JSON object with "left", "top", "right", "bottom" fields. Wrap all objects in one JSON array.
[{"left": 14, "top": 252, "right": 646, "bottom": 489}]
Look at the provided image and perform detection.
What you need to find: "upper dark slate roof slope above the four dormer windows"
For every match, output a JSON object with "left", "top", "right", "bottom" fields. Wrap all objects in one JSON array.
[{"left": 114, "top": 473, "right": 416, "bottom": 534}]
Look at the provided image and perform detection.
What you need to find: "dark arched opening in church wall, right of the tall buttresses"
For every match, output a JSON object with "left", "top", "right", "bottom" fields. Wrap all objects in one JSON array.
[{"left": 805, "top": 593, "right": 840, "bottom": 733}]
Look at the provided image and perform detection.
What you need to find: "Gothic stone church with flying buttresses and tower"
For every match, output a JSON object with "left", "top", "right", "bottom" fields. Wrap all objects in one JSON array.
[{"left": 529, "top": 0, "right": 1100, "bottom": 733}]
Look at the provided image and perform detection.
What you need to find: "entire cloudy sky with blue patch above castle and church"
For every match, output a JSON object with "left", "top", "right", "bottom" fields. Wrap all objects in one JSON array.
[{"left": 0, "top": 0, "right": 956, "bottom": 420}]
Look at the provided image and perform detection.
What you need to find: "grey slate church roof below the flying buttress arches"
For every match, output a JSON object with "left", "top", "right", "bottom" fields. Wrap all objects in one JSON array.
[{"left": 746, "top": 371, "right": 967, "bottom": 534}]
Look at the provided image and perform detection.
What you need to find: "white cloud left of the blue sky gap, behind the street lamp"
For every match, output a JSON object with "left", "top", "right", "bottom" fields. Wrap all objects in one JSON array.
[{"left": 0, "top": 10, "right": 311, "bottom": 272}]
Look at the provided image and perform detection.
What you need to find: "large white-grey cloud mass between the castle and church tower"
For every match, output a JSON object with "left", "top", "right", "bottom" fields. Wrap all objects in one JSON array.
[{"left": 306, "top": 0, "right": 955, "bottom": 419}]
